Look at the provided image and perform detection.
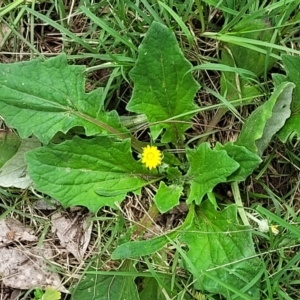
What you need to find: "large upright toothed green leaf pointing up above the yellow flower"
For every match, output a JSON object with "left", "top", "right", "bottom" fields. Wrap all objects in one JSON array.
[{"left": 127, "top": 22, "right": 199, "bottom": 144}]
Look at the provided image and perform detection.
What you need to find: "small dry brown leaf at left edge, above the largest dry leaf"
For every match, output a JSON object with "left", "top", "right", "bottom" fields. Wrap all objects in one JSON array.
[{"left": 0, "top": 218, "right": 38, "bottom": 247}]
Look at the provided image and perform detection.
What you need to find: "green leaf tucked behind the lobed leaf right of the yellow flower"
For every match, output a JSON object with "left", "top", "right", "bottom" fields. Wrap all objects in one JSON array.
[{"left": 215, "top": 142, "right": 262, "bottom": 181}]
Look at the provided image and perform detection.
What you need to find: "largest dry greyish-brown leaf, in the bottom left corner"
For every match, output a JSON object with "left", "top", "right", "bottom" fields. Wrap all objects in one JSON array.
[{"left": 0, "top": 245, "right": 69, "bottom": 293}]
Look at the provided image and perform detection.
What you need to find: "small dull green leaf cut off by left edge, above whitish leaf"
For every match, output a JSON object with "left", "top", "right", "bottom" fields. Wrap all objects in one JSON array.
[{"left": 0, "top": 131, "right": 21, "bottom": 168}]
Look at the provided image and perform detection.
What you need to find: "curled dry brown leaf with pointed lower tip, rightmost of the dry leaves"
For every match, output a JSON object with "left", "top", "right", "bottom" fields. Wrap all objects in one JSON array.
[{"left": 51, "top": 212, "right": 92, "bottom": 261}]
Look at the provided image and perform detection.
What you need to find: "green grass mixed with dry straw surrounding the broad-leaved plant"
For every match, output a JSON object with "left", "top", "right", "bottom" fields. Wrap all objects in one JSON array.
[{"left": 0, "top": 0, "right": 300, "bottom": 300}]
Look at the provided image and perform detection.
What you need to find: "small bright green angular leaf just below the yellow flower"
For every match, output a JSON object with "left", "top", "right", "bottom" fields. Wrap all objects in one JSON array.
[{"left": 153, "top": 181, "right": 183, "bottom": 214}]
